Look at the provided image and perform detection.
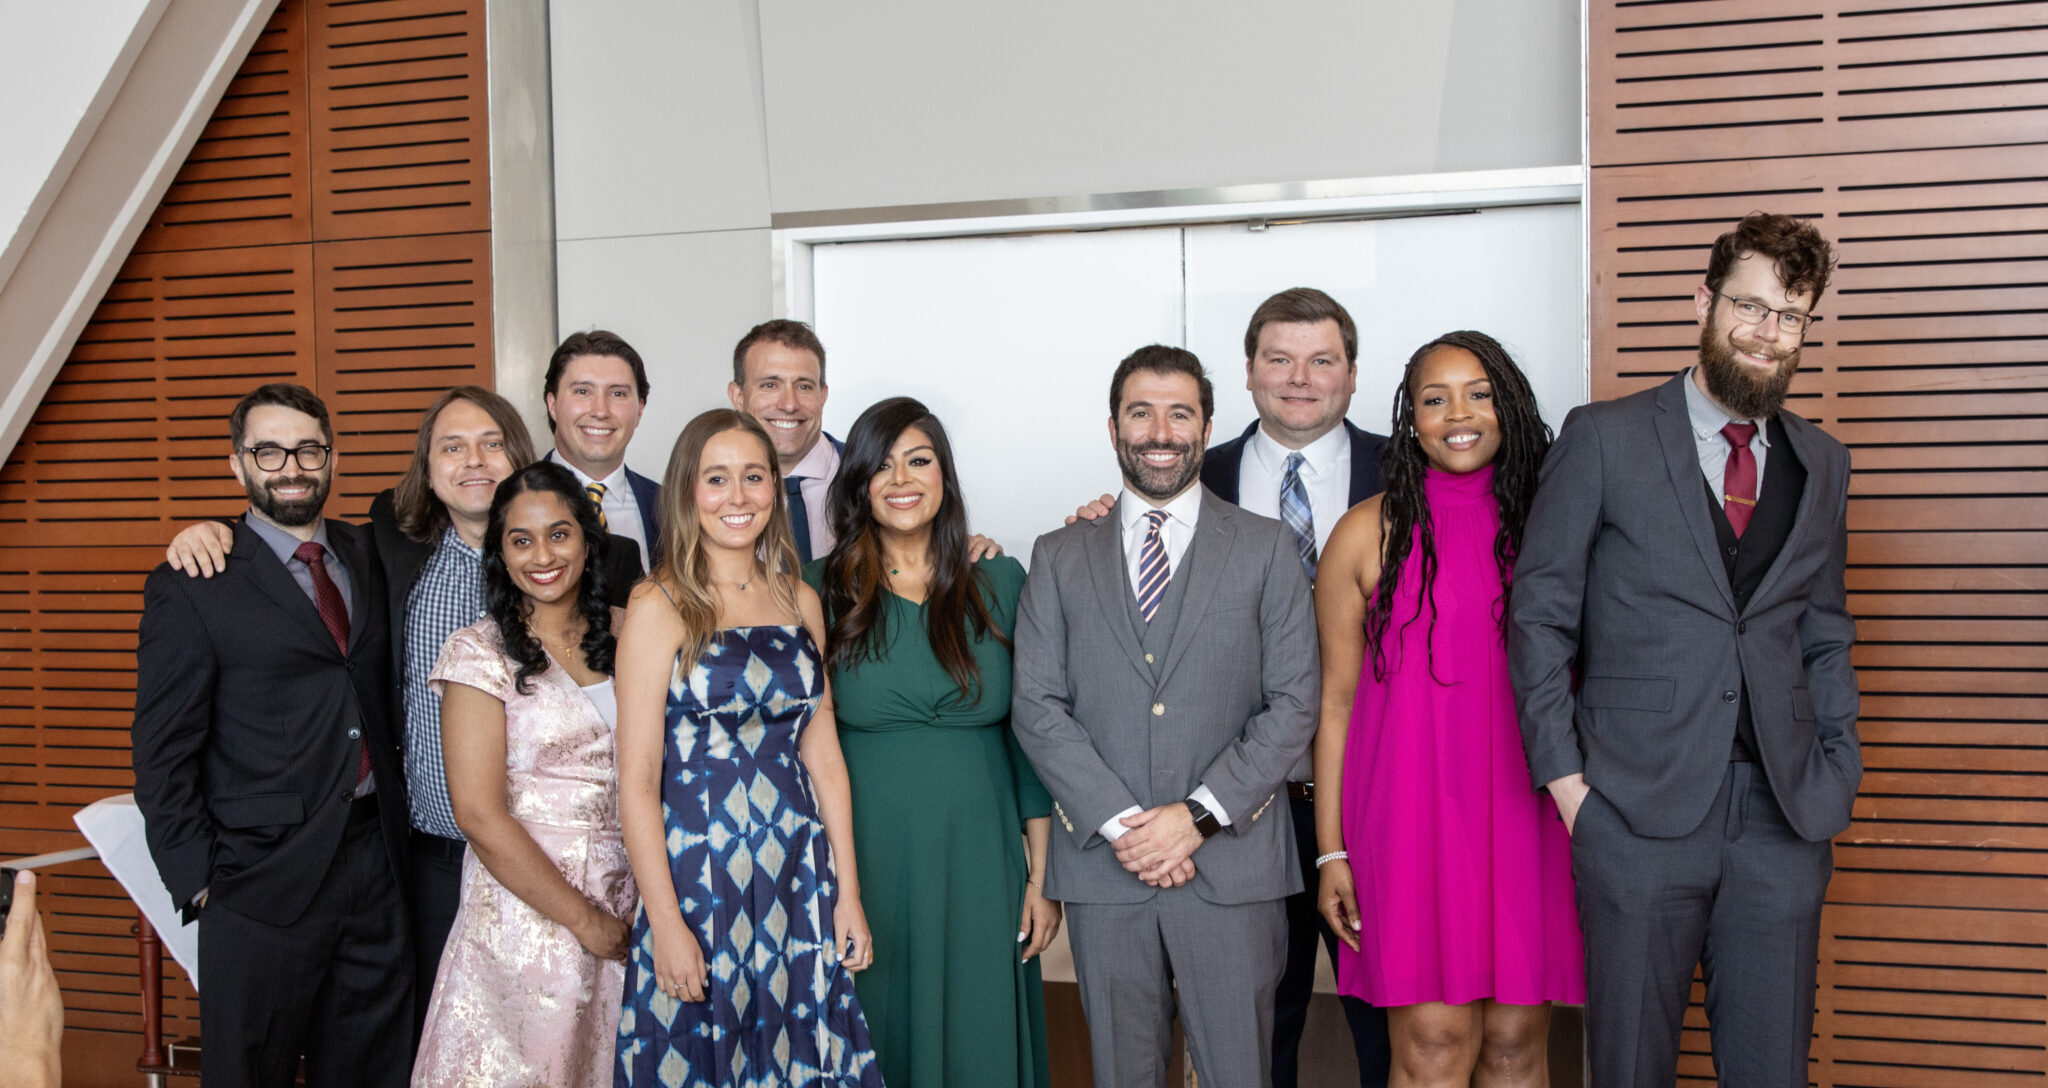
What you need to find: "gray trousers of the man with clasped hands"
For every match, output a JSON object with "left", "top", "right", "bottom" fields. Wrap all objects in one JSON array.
[{"left": 1067, "top": 887, "right": 1286, "bottom": 1088}]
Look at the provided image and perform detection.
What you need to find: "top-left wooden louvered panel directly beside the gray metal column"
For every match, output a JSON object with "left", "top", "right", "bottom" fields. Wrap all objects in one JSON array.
[{"left": 311, "top": 0, "right": 492, "bottom": 240}]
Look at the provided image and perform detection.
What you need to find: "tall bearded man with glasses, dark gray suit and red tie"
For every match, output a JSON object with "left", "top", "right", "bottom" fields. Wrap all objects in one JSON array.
[{"left": 1507, "top": 213, "right": 1864, "bottom": 1088}]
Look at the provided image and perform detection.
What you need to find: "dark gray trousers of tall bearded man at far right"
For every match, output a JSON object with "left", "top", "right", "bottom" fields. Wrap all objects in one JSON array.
[{"left": 1571, "top": 762, "right": 1835, "bottom": 1088}]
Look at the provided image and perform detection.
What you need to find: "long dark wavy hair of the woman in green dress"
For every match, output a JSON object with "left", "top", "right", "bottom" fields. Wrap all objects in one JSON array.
[{"left": 821, "top": 397, "right": 1010, "bottom": 701}]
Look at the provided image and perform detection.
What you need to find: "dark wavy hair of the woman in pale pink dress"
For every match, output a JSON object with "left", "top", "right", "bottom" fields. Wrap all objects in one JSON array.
[{"left": 483, "top": 461, "right": 618, "bottom": 695}]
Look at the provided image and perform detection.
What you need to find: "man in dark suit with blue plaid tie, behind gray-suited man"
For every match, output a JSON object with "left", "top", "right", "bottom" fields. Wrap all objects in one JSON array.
[{"left": 1075, "top": 287, "right": 1393, "bottom": 1088}]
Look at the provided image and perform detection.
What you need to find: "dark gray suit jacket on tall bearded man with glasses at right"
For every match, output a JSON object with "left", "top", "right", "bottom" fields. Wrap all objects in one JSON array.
[{"left": 1507, "top": 375, "right": 1864, "bottom": 842}]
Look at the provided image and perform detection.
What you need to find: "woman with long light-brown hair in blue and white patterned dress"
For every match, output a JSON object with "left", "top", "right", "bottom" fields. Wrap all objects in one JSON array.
[{"left": 612, "top": 410, "right": 881, "bottom": 1088}]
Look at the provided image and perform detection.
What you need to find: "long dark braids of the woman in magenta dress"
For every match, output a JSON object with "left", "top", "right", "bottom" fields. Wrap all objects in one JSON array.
[{"left": 1366, "top": 330, "right": 1550, "bottom": 680}]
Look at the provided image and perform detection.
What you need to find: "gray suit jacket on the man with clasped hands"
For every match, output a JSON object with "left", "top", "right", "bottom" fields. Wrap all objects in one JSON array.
[{"left": 1012, "top": 492, "right": 1321, "bottom": 904}]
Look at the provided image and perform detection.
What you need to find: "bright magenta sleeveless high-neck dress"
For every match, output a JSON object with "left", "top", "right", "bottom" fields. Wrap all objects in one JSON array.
[{"left": 1337, "top": 465, "right": 1585, "bottom": 1008}]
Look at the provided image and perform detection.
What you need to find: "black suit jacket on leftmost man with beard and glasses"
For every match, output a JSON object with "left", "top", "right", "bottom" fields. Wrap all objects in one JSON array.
[{"left": 133, "top": 520, "right": 406, "bottom": 926}]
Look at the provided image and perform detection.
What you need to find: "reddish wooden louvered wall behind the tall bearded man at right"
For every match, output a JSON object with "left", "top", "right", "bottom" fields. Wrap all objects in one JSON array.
[{"left": 1587, "top": 0, "right": 2048, "bottom": 1088}]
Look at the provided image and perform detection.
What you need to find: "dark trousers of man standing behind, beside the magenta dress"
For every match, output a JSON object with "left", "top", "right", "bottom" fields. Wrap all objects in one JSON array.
[{"left": 1274, "top": 797, "right": 1395, "bottom": 1088}]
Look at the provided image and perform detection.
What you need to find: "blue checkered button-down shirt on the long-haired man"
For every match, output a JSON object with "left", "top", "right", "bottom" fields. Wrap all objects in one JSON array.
[{"left": 406, "top": 527, "right": 483, "bottom": 838}]
